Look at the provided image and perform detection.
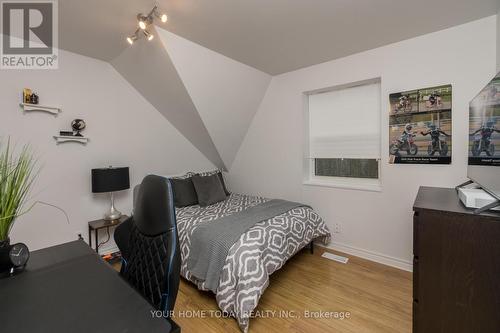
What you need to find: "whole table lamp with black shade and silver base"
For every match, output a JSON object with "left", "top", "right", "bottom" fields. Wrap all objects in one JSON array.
[{"left": 92, "top": 166, "right": 130, "bottom": 221}]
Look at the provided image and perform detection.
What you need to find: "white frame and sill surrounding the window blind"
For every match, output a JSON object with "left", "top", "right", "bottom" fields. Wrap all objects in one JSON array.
[{"left": 302, "top": 77, "right": 383, "bottom": 192}]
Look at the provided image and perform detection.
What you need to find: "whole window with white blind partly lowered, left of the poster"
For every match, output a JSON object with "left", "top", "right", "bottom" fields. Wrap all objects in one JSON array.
[{"left": 305, "top": 79, "right": 380, "bottom": 190}]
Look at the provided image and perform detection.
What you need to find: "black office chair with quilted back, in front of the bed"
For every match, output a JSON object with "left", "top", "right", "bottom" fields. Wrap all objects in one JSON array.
[{"left": 115, "top": 175, "right": 181, "bottom": 317}]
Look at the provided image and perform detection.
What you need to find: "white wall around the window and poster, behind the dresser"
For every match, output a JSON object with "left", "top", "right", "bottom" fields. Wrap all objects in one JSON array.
[{"left": 229, "top": 16, "right": 497, "bottom": 269}]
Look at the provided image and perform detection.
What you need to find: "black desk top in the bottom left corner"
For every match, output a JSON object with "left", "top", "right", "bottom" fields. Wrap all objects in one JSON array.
[{"left": 0, "top": 241, "right": 179, "bottom": 333}]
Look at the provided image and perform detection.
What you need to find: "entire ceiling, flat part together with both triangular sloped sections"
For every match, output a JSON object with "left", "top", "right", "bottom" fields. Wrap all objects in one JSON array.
[{"left": 52, "top": 0, "right": 498, "bottom": 169}]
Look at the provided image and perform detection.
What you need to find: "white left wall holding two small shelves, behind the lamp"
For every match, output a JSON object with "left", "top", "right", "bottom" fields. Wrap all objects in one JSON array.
[{"left": 0, "top": 51, "right": 214, "bottom": 250}]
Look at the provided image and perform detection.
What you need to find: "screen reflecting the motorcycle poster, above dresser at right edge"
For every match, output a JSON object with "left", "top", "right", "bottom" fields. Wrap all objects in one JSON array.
[{"left": 469, "top": 73, "right": 500, "bottom": 166}]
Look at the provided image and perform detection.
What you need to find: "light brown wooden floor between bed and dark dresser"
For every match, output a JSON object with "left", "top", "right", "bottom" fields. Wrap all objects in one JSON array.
[{"left": 115, "top": 247, "right": 412, "bottom": 333}]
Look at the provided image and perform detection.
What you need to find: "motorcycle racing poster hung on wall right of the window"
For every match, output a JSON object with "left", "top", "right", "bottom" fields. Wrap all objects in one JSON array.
[{"left": 389, "top": 85, "right": 452, "bottom": 164}]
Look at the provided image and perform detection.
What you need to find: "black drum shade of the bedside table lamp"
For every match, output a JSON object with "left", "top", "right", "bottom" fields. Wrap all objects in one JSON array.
[{"left": 92, "top": 167, "right": 130, "bottom": 193}]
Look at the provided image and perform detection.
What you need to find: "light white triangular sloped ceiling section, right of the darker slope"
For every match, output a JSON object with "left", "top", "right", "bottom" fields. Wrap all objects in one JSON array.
[{"left": 156, "top": 28, "right": 271, "bottom": 168}]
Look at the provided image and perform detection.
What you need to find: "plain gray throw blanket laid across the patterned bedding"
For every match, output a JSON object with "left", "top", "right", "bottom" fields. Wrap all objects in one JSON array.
[{"left": 187, "top": 200, "right": 309, "bottom": 293}]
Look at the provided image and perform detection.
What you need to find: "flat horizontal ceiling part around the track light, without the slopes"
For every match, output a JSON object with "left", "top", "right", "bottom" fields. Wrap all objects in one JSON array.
[{"left": 59, "top": 0, "right": 498, "bottom": 74}]
